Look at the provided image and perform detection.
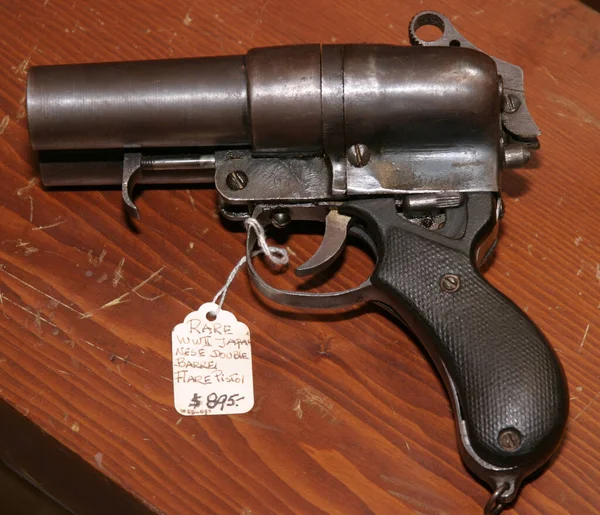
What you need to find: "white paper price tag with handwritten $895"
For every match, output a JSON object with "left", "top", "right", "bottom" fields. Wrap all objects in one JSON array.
[{"left": 171, "top": 302, "right": 254, "bottom": 416}]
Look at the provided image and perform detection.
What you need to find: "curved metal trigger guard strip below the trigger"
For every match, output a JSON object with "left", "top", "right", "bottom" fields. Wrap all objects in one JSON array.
[{"left": 246, "top": 219, "right": 377, "bottom": 309}]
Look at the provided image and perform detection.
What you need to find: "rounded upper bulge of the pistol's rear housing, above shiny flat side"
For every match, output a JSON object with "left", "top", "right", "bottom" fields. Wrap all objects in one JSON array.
[{"left": 344, "top": 45, "right": 500, "bottom": 150}]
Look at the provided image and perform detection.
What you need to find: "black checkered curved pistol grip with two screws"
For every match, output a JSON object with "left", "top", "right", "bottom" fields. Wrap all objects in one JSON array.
[{"left": 340, "top": 194, "right": 569, "bottom": 499}]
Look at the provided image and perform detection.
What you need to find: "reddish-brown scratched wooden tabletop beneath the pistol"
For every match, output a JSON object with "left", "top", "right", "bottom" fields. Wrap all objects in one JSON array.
[{"left": 0, "top": 0, "right": 600, "bottom": 515}]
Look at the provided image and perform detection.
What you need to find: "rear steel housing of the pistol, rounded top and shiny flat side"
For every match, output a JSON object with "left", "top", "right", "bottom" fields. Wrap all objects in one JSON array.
[{"left": 344, "top": 45, "right": 502, "bottom": 195}]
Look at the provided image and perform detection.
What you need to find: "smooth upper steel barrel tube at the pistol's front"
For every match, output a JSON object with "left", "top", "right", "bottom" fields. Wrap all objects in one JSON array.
[{"left": 27, "top": 56, "right": 250, "bottom": 150}]
